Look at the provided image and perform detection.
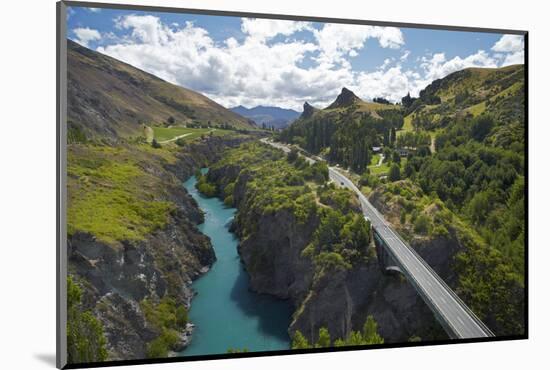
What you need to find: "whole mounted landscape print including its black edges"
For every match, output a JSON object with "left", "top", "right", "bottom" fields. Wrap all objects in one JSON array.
[{"left": 57, "top": 2, "right": 527, "bottom": 368}]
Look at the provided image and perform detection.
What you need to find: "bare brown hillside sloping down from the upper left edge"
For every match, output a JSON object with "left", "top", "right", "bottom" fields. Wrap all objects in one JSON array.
[{"left": 67, "top": 40, "right": 255, "bottom": 141}]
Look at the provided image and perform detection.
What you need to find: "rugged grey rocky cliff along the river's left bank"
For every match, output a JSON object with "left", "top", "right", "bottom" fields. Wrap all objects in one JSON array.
[{"left": 67, "top": 137, "right": 250, "bottom": 360}]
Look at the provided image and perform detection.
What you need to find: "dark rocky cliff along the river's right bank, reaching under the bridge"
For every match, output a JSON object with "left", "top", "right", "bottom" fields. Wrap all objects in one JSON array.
[{"left": 208, "top": 157, "right": 446, "bottom": 342}]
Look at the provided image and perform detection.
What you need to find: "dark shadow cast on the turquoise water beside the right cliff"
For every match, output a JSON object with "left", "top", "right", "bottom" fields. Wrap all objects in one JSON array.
[{"left": 230, "top": 257, "right": 292, "bottom": 341}]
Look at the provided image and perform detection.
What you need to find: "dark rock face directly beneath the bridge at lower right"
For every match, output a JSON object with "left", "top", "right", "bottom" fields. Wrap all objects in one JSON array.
[{"left": 289, "top": 259, "right": 446, "bottom": 343}]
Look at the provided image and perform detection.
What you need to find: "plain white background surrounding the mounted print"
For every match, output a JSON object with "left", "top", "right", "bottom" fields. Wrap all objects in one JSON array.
[{"left": 0, "top": 0, "right": 550, "bottom": 370}]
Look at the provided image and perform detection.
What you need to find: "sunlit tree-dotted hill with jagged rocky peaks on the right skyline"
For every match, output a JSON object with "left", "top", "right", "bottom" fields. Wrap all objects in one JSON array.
[{"left": 281, "top": 65, "right": 525, "bottom": 162}]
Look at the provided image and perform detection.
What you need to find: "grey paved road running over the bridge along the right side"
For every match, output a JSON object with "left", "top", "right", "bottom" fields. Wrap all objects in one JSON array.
[{"left": 262, "top": 139, "right": 494, "bottom": 338}]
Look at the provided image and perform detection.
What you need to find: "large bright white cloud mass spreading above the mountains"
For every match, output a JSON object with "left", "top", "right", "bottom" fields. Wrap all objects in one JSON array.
[{"left": 91, "top": 15, "right": 523, "bottom": 110}]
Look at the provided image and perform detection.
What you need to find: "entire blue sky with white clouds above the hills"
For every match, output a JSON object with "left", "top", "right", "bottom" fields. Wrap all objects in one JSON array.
[{"left": 67, "top": 7, "right": 523, "bottom": 110}]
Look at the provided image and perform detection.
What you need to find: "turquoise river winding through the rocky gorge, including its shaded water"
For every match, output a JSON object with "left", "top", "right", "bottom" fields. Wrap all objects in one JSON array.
[{"left": 181, "top": 169, "right": 292, "bottom": 356}]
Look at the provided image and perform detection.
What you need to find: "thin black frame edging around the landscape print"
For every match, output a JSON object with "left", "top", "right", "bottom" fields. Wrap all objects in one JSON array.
[{"left": 56, "top": 1, "right": 529, "bottom": 369}]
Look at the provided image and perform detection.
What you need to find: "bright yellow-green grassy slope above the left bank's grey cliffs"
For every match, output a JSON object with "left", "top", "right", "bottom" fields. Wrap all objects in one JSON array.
[{"left": 67, "top": 144, "right": 175, "bottom": 244}]
